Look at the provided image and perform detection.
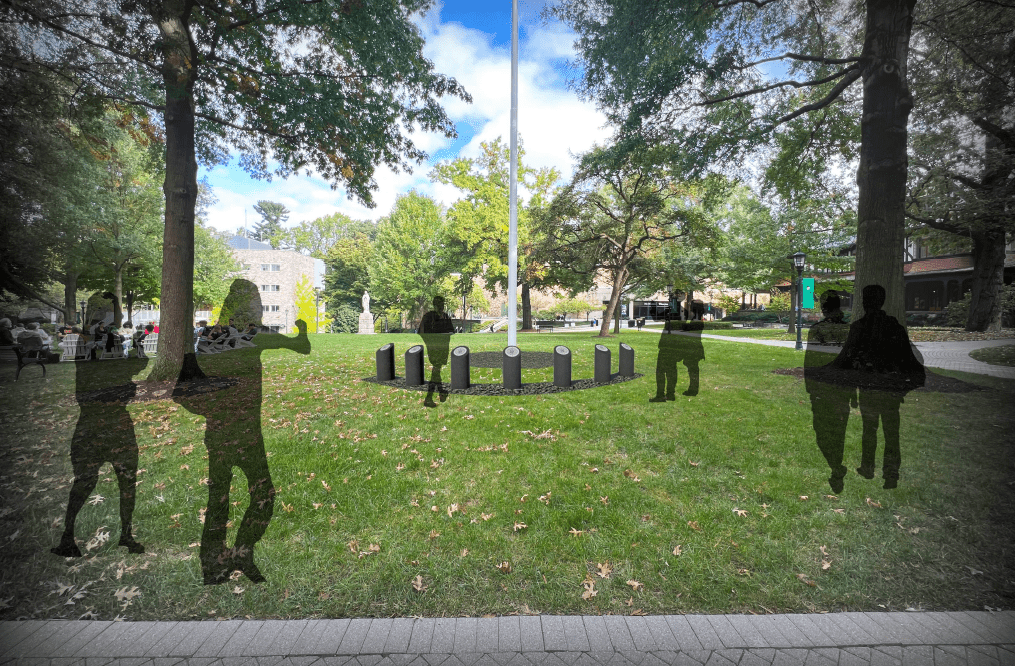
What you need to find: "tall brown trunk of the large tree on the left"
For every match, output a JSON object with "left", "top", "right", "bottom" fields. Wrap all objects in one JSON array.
[{"left": 148, "top": 0, "right": 204, "bottom": 381}]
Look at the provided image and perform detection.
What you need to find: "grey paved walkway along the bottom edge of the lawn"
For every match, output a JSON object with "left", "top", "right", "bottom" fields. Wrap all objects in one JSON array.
[{"left": 0, "top": 611, "right": 1015, "bottom": 666}]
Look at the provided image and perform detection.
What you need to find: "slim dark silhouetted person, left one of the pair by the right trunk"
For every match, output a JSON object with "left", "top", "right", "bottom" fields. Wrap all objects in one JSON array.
[{"left": 804, "top": 291, "right": 857, "bottom": 493}]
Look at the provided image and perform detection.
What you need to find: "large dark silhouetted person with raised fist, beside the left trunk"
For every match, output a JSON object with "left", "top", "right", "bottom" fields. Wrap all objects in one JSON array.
[{"left": 174, "top": 279, "right": 311, "bottom": 585}]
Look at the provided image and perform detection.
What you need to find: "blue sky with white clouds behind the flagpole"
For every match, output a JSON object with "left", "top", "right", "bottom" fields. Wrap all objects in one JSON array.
[{"left": 200, "top": 0, "right": 609, "bottom": 235}]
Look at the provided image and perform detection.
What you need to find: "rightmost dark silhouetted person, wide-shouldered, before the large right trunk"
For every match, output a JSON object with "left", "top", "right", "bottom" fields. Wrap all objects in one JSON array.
[{"left": 832, "top": 284, "right": 926, "bottom": 488}]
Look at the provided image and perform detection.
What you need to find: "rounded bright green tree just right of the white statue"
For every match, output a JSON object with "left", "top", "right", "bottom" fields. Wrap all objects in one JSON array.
[{"left": 368, "top": 190, "right": 455, "bottom": 320}]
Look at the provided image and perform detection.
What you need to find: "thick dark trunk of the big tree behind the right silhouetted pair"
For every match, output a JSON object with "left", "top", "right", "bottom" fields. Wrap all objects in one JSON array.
[{"left": 853, "top": 0, "right": 916, "bottom": 326}]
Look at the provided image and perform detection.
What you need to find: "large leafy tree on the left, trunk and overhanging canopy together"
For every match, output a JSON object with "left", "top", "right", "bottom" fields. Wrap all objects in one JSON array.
[{"left": 2, "top": 0, "right": 469, "bottom": 380}]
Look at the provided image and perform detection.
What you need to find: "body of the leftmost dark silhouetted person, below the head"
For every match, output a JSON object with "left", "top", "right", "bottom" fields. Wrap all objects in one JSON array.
[{"left": 51, "top": 294, "right": 148, "bottom": 557}]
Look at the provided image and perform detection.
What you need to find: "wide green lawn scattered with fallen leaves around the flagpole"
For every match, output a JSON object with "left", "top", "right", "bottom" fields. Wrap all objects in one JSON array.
[{"left": 0, "top": 331, "right": 1015, "bottom": 620}]
